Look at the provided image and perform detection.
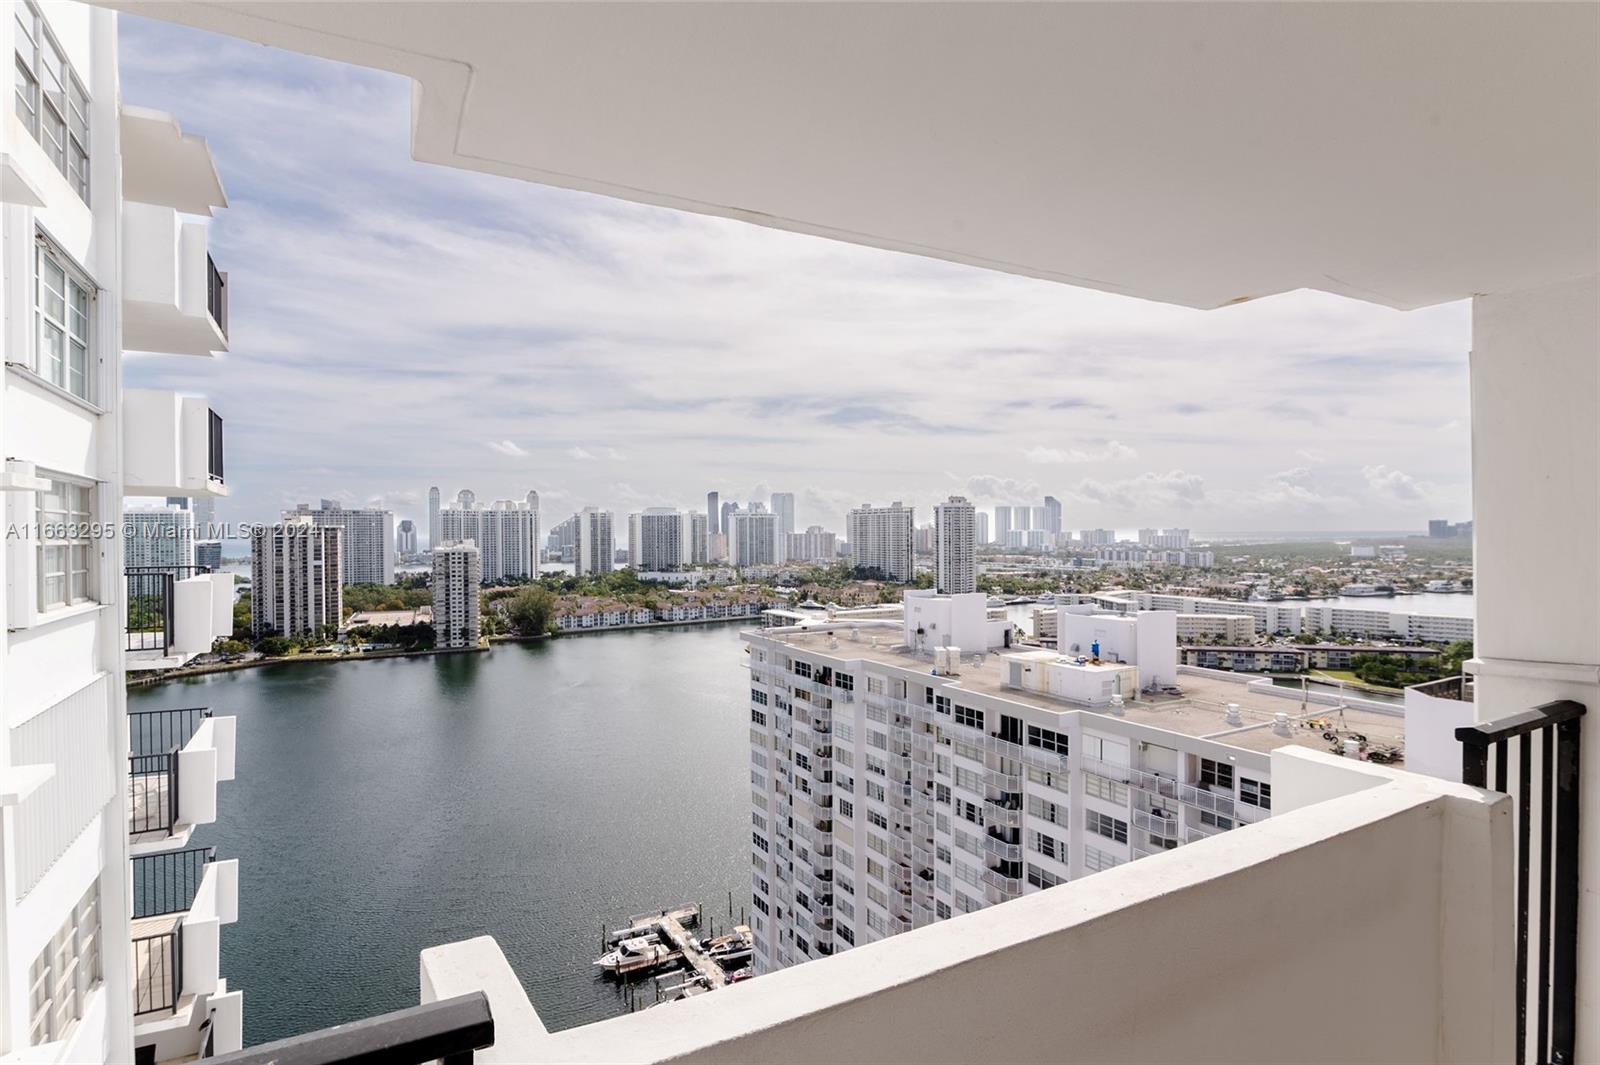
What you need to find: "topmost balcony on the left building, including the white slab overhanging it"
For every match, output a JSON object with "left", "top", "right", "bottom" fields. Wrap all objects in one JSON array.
[{"left": 120, "top": 107, "right": 227, "bottom": 355}]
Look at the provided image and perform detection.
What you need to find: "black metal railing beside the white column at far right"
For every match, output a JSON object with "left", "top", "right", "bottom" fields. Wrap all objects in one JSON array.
[{"left": 1456, "top": 699, "right": 1584, "bottom": 1065}]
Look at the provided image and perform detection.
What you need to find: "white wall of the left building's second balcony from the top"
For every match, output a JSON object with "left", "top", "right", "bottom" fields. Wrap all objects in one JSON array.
[{"left": 122, "top": 389, "right": 227, "bottom": 496}]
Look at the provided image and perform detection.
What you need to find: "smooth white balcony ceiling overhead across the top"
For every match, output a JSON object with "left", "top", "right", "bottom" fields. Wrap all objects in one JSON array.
[{"left": 106, "top": 2, "right": 1600, "bottom": 307}]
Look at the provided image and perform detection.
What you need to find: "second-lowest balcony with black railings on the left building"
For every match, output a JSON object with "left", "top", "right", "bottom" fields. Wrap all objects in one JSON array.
[{"left": 128, "top": 707, "right": 237, "bottom": 856}]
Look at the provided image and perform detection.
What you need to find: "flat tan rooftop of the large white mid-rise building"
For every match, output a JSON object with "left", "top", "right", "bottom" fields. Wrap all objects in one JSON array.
[{"left": 750, "top": 627, "right": 1405, "bottom": 753}]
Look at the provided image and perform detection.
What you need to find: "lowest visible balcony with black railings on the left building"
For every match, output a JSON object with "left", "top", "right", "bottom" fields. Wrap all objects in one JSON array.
[{"left": 130, "top": 848, "right": 243, "bottom": 1063}]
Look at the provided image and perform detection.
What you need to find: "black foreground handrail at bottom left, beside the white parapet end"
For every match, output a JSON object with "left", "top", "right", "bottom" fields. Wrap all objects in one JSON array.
[{"left": 211, "top": 991, "right": 494, "bottom": 1065}]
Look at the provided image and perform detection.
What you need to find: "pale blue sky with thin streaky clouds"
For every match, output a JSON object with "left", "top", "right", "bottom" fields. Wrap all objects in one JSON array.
[{"left": 122, "top": 14, "right": 1470, "bottom": 533}]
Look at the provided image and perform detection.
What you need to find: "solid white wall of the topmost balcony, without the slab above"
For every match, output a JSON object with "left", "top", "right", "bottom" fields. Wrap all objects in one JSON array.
[{"left": 122, "top": 201, "right": 227, "bottom": 355}]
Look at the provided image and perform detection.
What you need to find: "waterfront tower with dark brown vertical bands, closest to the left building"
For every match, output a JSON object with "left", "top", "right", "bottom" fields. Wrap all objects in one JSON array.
[{"left": 250, "top": 515, "right": 344, "bottom": 636}]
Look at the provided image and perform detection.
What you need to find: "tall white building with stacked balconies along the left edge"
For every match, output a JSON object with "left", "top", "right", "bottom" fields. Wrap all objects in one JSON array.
[{"left": 0, "top": 8, "right": 243, "bottom": 1065}]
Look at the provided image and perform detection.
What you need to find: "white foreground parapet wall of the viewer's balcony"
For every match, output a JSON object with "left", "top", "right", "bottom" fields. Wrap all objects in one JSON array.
[{"left": 421, "top": 748, "right": 1515, "bottom": 1063}]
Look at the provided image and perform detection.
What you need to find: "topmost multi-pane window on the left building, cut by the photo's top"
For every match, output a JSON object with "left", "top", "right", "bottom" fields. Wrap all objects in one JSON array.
[{"left": 16, "top": 0, "right": 90, "bottom": 203}]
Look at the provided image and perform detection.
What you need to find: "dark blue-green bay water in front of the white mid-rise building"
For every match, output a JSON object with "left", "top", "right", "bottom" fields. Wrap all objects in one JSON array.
[{"left": 128, "top": 625, "right": 750, "bottom": 1044}]
